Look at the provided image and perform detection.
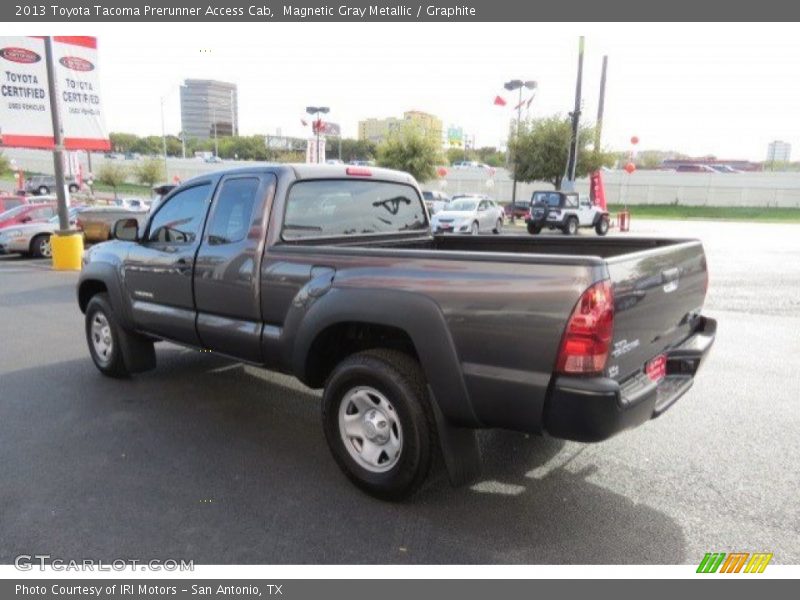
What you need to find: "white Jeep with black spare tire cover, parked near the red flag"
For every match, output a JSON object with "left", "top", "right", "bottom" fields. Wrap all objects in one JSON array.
[{"left": 525, "top": 191, "right": 610, "bottom": 235}]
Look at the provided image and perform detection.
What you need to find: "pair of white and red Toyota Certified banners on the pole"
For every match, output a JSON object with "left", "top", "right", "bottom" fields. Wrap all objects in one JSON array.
[{"left": 0, "top": 36, "right": 111, "bottom": 150}]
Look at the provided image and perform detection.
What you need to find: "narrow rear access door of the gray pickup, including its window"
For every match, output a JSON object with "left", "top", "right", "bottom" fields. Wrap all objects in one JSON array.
[{"left": 194, "top": 173, "right": 276, "bottom": 363}]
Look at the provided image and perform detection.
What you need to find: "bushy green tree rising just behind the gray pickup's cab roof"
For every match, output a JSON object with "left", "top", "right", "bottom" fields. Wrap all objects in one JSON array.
[{"left": 377, "top": 123, "right": 444, "bottom": 183}]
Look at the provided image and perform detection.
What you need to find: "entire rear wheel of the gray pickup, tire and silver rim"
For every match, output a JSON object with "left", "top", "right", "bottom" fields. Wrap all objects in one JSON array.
[{"left": 322, "top": 349, "right": 436, "bottom": 500}]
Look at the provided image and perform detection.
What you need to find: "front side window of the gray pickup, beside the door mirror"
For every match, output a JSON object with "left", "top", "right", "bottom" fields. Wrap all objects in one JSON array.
[{"left": 147, "top": 183, "right": 211, "bottom": 244}]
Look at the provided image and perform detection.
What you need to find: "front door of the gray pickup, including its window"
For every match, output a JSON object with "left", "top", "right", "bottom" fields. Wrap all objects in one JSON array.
[{"left": 123, "top": 180, "right": 212, "bottom": 345}]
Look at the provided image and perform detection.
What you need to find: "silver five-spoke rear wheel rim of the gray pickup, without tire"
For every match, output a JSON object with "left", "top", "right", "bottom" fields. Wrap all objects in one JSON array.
[{"left": 339, "top": 386, "right": 403, "bottom": 473}]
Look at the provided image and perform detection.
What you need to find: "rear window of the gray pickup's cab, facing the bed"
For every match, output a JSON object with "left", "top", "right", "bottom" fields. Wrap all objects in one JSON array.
[{"left": 282, "top": 179, "right": 428, "bottom": 240}]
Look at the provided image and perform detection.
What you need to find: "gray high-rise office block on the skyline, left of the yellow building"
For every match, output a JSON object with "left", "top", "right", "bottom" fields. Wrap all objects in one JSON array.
[{"left": 181, "top": 79, "right": 239, "bottom": 139}]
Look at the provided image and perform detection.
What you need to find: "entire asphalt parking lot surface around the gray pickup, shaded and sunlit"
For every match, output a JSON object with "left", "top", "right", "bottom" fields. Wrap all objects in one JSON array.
[{"left": 0, "top": 221, "right": 800, "bottom": 564}]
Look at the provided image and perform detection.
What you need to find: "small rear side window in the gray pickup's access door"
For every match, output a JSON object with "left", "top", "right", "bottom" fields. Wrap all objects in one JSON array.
[{"left": 208, "top": 177, "right": 259, "bottom": 246}]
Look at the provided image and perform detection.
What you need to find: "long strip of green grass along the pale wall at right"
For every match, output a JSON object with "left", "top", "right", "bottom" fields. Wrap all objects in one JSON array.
[{"left": 608, "top": 204, "right": 800, "bottom": 223}]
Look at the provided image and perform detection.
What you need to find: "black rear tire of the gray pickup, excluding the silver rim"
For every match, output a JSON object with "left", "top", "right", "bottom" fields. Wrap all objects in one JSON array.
[{"left": 322, "top": 349, "right": 438, "bottom": 500}]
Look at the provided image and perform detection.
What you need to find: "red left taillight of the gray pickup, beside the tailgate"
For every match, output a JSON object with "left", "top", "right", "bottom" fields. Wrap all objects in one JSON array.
[{"left": 556, "top": 280, "right": 614, "bottom": 375}]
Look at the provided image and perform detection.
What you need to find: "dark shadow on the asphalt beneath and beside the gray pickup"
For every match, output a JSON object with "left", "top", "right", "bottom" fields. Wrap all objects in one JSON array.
[{"left": 0, "top": 345, "right": 685, "bottom": 564}]
